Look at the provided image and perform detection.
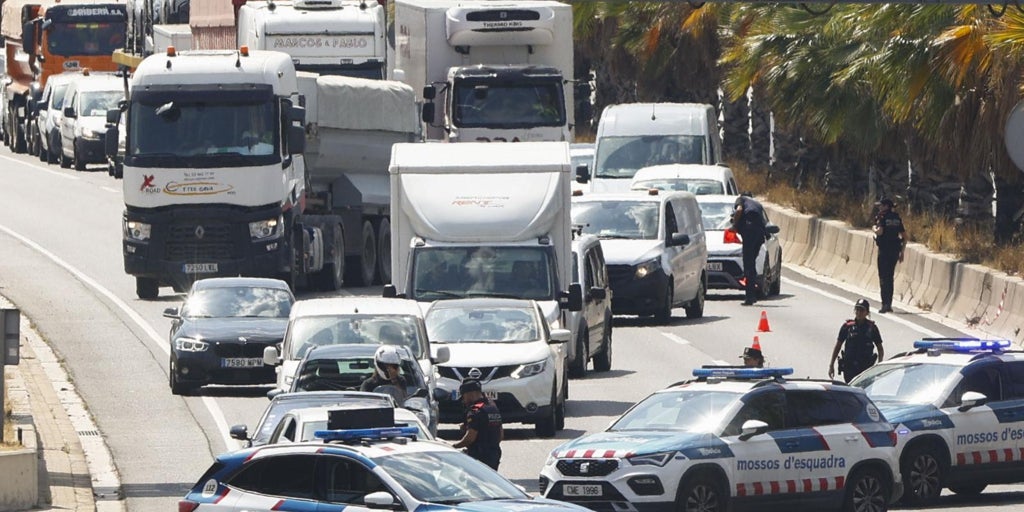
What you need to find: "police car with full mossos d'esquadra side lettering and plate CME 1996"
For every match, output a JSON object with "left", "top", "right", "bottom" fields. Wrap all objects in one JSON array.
[{"left": 540, "top": 367, "right": 901, "bottom": 512}]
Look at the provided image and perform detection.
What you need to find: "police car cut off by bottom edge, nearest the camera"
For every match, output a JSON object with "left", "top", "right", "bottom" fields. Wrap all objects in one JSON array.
[{"left": 178, "top": 408, "right": 586, "bottom": 512}]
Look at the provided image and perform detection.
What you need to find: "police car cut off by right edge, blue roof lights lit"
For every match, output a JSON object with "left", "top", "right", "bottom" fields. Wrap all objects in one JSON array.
[{"left": 851, "top": 338, "right": 1024, "bottom": 505}]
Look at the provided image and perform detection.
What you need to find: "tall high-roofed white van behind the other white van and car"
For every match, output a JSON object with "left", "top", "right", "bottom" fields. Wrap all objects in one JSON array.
[{"left": 577, "top": 103, "right": 722, "bottom": 191}]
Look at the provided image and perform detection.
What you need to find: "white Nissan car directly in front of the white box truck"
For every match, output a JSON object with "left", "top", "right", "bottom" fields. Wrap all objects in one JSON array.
[{"left": 425, "top": 298, "right": 571, "bottom": 437}]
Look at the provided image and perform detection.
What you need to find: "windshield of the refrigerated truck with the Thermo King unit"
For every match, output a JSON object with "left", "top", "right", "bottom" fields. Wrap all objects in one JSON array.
[{"left": 453, "top": 82, "right": 565, "bottom": 128}]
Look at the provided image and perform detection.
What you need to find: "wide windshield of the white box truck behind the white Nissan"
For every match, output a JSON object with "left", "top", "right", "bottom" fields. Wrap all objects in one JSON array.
[{"left": 410, "top": 246, "right": 556, "bottom": 301}]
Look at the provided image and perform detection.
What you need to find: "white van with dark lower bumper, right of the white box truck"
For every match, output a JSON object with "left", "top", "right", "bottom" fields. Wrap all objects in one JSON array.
[{"left": 572, "top": 189, "right": 708, "bottom": 324}]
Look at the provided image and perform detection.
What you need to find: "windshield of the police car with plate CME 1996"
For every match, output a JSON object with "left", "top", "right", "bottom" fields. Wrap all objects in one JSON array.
[{"left": 608, "top": 390, "right": 742, "bottom": 433}]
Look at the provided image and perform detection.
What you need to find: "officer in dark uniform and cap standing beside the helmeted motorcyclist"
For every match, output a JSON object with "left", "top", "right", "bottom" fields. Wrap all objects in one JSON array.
[{"left": 453, "top": 379, "right": 505, "bottom": 471}]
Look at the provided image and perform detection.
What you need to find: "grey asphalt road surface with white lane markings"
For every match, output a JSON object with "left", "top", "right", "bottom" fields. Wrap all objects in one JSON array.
[{"left": 0, "top": 150, "right": 1024, "bottom": 511}]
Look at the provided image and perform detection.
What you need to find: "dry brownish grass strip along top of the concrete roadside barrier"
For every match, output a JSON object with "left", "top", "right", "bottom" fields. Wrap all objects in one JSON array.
[{"left": 729, "top": 162, "right": 1024, "bottom": 275}]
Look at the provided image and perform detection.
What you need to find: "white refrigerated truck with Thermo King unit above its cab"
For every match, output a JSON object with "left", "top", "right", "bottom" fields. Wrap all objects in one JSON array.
[{"left": 391, "top": 0, "right": 573, "bottom": 142}]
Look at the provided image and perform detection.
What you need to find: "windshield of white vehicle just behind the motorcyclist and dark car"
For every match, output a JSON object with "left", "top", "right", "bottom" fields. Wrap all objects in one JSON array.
[{"left": 285, "top": 314, "right": 427, "bottom": 359}]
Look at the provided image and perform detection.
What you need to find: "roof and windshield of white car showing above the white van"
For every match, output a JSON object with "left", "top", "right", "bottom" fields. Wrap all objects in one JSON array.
[{"left": 630, "top": 164, "right": 739, "bottom": 196}]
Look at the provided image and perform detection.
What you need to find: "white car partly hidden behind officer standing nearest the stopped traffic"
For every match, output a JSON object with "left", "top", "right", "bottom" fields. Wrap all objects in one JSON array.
[{"left": 697, "top": 196, "right": 782, "bottom": 298}]
